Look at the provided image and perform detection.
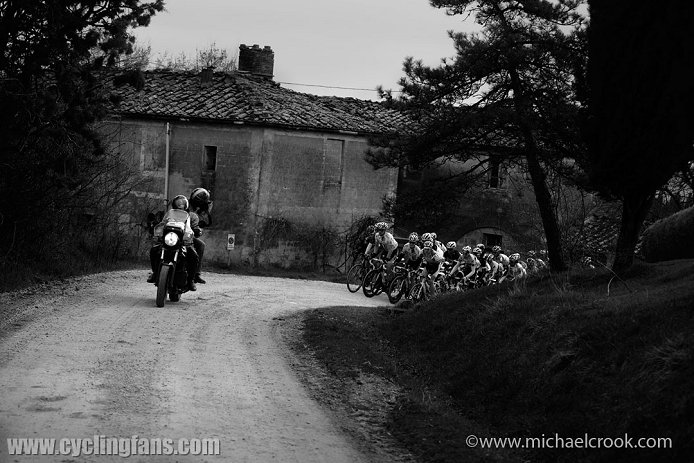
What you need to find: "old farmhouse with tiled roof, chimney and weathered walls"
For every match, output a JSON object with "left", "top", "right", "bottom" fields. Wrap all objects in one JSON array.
[{"left": 101, "top": 45, "right": 405, "bottom": 265}]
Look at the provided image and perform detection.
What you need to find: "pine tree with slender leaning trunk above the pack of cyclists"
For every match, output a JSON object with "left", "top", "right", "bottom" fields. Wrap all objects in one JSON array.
[{"left": 369, "top": 0, "right": 585, "bottom": 270}]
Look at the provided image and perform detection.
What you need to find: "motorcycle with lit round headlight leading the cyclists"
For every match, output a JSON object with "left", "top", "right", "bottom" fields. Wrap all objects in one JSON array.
[{"left": 154, "top": 209, "right": 188, "bottom": 307}]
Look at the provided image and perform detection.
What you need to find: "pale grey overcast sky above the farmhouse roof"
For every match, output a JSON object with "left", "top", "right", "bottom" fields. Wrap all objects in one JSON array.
[{"left": 129, "top": 0, "right": 474, "bottom": 99}]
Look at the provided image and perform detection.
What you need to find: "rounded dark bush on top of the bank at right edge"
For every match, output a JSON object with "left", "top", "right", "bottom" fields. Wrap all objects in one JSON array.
[{"left": 641, "top": 207, "right": 694, "bottom": 262}]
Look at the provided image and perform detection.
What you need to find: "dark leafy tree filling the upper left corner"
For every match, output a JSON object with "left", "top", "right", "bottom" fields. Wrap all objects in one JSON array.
[{"left": 0, "top": 0, "right": 164, "bottom": 268}]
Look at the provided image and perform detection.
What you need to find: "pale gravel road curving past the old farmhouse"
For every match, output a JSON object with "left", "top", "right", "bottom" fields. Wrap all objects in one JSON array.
[{"left": 0, "top": 270, "right": 387, "bottom": 462}]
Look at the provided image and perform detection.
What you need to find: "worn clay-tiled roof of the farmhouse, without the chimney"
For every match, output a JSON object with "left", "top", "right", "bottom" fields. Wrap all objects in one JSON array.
[{"left": 107, "top": 71, "right": 407, "bottom": 134}]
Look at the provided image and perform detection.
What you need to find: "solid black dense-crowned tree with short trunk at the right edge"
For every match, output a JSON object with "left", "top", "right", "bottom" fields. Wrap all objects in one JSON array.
[{"left": 583, "top": 0, "right": 694, "bottom": 271}]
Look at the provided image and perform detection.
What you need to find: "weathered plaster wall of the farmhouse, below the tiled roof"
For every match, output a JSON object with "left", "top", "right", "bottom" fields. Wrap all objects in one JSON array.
[{"left": 101, "top": 121, "right": 397, "bottom": 263}]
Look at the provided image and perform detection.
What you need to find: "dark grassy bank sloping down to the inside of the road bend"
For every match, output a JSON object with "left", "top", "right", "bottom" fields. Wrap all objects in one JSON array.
[{"left": 304, "top": 260, "right": 694, "bottom": 461}]
